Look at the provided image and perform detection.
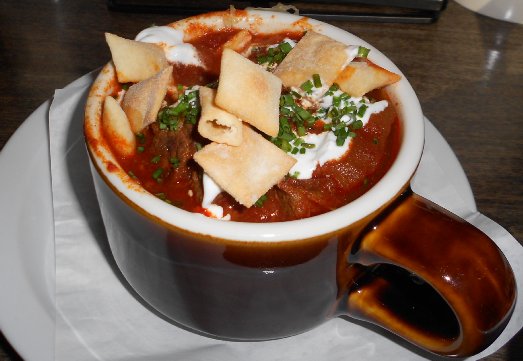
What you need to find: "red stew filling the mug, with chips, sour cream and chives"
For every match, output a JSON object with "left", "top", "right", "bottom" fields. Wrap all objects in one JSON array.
[{"left": 102, "top": 26, "right": 400, "bottom": 222}]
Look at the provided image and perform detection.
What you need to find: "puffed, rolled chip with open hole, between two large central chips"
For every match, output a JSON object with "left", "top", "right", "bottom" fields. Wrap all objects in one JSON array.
[{"left": 198, "top": 87, "right": 242, "bottom": 146}]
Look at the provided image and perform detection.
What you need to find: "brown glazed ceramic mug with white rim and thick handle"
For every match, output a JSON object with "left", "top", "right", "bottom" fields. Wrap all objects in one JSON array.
[{"left": 85, "top": 11, "right": 516, "bottom": 356}]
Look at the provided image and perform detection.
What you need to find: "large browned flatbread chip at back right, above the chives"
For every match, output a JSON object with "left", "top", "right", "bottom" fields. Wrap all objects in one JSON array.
[{"left": 274, "top": 30, "right": 348, "bottom": 87}]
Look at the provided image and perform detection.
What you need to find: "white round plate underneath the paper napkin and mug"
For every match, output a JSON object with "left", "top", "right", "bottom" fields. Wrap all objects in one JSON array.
[{"left": 0, "top": 76, "right": 476, "bottom": 361}]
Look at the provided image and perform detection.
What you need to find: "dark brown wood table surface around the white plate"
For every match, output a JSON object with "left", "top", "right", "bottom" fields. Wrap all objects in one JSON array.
[{"left": 0, "top": 0, "right": 523, "bottom": 361}]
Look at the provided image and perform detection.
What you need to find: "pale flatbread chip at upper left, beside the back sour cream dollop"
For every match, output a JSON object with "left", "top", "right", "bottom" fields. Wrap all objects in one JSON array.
[{"left": 105, "top": 33, "right": 169, "bottom": 83}]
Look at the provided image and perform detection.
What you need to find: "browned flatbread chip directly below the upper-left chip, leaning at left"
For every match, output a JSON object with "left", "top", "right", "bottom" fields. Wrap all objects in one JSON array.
[{"left": 122, "top": 66, "right": 173, "bottom": 133}]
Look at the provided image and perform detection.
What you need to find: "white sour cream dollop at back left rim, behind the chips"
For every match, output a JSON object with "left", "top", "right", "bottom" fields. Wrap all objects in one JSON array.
[{"left": 135, "top": 26, "right": 203, "bottom": 66}]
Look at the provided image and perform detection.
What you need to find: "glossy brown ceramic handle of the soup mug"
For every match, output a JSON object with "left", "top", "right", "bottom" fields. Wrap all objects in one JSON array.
[{"left": 347, "top": 187, "right": 516, "bottom": 357}]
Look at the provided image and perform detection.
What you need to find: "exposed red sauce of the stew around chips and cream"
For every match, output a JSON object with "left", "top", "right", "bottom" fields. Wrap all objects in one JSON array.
[{"left": 105, "top": 30, "right": 401, "bottom": 222}]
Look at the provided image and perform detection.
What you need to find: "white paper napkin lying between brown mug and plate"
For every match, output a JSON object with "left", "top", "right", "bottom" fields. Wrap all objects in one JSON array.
[{"left": 49, "top": 74, "right": 523, "bottom": 361}]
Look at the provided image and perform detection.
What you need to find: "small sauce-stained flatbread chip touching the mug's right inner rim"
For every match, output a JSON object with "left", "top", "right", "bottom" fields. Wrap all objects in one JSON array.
[{"left": 334, "top": 59, "right": 401, "bottom": 97}]
